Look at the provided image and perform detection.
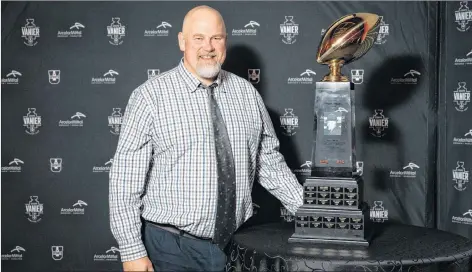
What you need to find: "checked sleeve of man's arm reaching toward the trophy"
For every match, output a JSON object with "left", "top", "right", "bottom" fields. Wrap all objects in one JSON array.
[{"left": 255, "top": 91, "right": 303, "bottom": 214}]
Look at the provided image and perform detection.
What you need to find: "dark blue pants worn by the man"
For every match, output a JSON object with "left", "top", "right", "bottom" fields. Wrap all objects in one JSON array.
[{"left": 143, "top": 223, "right": 226, "bottom": 272}]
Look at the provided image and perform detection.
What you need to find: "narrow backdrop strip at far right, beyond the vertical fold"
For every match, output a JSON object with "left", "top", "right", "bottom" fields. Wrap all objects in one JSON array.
[{"left": 435, "top": 1, "right": 472, "bottom": 242}]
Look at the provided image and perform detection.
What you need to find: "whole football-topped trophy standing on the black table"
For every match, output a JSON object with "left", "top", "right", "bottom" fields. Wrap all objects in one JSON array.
[{"left": 289, "top": 13, "right": 380, "bottom": 246}]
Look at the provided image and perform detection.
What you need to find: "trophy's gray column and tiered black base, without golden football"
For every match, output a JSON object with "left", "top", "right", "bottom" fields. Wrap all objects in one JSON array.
[{"left": 289, "top": 82, "right": 369, "bottom": 245}]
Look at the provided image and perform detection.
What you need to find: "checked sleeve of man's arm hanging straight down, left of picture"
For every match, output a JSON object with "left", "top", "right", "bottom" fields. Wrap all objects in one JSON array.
[{"left": 109, "top": 89, "right": 152, "bottom": 262}]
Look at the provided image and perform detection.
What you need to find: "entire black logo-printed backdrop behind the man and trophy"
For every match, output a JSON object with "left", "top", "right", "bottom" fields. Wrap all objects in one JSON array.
[{"left": 1, "top": 1, "right": 472, "bottom": 271}]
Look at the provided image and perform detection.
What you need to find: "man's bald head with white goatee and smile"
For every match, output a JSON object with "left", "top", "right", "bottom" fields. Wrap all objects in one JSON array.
[{"left": 178, "top": 6, "right": 226, "bottom": 83}]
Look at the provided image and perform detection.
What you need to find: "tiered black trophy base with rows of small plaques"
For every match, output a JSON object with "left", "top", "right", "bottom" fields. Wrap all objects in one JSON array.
[{"left": 288, "top": 176, "right": 369, "bottom": 246}]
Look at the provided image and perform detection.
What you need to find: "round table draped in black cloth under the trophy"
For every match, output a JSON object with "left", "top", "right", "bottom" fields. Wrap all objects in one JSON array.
[{"left": 226, "top": 222, "right": 472, "bottom": 272}]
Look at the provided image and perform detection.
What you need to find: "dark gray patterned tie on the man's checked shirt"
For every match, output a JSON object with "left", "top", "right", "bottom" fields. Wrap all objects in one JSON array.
[{"left": 205, "top": 83, "right": 236, "bottom": 250}]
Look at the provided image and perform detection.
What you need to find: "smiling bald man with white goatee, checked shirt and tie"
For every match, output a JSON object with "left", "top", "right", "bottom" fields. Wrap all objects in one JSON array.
[{"left": 109, "top": 6, "right": 303, "bottom": 271}]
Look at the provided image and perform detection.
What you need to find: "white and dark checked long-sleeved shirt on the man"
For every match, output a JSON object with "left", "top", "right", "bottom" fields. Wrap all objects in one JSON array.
[{"left": 109, "top": 60, "right": 303, "bottom": 262}]
